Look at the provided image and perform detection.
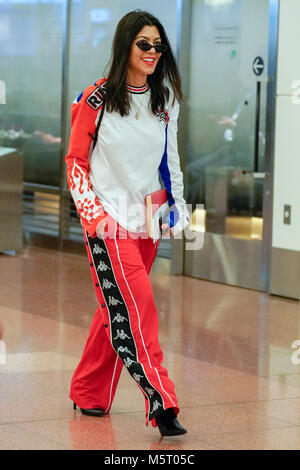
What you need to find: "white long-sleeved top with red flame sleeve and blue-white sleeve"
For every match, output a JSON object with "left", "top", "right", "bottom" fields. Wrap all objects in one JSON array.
[{"left": 66, "top": 78, "right": 190, "bottom": 236}]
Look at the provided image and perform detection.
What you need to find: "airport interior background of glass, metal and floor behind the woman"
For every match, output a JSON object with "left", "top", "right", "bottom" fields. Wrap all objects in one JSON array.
[{"left": 0, "top": 0, "right": 300, "bottom": 452}]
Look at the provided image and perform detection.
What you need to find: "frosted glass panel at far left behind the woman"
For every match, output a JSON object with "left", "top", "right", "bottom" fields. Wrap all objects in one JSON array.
[{"left": 0, "top": 0, "right": 63, "bottom": 186}]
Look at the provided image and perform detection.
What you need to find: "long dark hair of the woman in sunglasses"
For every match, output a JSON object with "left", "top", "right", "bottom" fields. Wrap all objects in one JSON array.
[{"left": 104, "top": 9, "right": 183, "bottom": 116}]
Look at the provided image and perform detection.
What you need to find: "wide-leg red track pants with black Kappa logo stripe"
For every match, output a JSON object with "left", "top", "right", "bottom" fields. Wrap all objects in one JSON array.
[{"left": 70, "top": 218, "right": 179, "bottom": 427}]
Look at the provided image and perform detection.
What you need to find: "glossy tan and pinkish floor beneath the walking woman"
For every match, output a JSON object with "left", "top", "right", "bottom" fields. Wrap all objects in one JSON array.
[{"left": 0, "top": 247, "right": 300, "bottom": 450}]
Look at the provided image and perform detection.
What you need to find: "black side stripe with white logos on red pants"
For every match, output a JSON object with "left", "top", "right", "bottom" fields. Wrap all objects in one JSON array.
[{"left": 86, "top": 232, "right": 164, "bottom": 421}]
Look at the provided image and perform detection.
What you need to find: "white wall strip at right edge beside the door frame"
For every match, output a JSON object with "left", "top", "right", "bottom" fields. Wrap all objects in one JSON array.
[{"left": 272, "top": 0, "right": 300, "bottom": 251}]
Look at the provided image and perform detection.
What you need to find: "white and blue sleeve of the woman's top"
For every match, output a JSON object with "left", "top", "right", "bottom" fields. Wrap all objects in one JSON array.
[{"left": 159, "top": 94, "right": 190, "bottom": 230}]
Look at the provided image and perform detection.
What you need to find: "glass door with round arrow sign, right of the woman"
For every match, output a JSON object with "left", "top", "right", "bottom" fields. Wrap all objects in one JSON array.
[{"left": 184, "top": 0, "right": 269, "bottom": 290}]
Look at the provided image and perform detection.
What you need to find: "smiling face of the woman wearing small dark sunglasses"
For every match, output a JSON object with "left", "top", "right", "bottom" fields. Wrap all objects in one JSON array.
[{"left": 128, "top": 26, "right": 161, "bottom": 81}]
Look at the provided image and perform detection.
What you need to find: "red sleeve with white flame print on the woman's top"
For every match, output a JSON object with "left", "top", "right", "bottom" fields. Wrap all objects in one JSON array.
[{"left": 65, "top": 86, "right": 106, "bottom": 237}]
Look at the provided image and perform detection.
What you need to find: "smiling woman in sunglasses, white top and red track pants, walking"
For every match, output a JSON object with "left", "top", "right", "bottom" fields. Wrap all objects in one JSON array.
[{"left": 66, "top": 10, "right": 190, "bottom": 436}]
